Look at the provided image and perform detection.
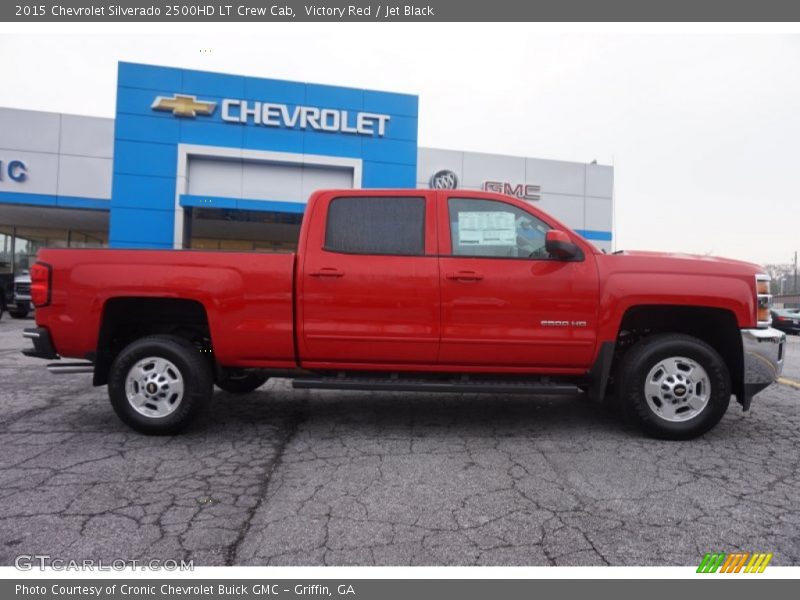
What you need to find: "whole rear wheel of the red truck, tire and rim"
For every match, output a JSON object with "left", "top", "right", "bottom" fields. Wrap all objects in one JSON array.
[{"left": 108, "top": 335, "right": 213, "bottom": 435}]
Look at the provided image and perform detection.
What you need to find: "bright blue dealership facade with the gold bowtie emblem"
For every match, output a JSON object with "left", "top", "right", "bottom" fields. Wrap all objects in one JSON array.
[{"left": 109, "top": 63, "right": 418, "bottom": 248}]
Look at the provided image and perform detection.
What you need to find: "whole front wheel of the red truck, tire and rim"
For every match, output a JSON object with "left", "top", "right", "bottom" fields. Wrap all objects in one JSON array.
[{"left": 618, "top": 334, "right": 731, "bottom": 440}]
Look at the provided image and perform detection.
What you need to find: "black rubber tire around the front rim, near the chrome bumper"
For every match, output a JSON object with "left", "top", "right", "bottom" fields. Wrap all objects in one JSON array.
[{"left": 616, "top": 334, "right": 731, "bottom": 440}]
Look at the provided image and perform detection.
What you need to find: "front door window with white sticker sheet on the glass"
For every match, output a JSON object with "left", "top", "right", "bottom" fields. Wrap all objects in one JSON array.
[{"left": 448, "top": 198, "right": 550, "bottom": 258}]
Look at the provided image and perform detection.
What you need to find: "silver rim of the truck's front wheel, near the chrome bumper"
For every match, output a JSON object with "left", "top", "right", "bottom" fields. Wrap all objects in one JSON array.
[{"left": 644, "top": 356, "right": 711, "bottom": 423}]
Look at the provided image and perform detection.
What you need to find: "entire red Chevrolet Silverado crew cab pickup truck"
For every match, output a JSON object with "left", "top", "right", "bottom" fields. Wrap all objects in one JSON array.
[{"left": 25, "top": 190, "right": 785, "bottom": 439}]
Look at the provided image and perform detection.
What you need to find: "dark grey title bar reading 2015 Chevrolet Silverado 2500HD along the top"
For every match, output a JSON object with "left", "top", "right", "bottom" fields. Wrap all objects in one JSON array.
[{"left": 0, "top": 0, "right": 800, "bottom": 23}]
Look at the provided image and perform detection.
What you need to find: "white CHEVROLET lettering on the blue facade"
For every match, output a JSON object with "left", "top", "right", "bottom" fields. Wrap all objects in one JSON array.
[{"left": 222, "top": 98, "right": 390, "bottom": 137}]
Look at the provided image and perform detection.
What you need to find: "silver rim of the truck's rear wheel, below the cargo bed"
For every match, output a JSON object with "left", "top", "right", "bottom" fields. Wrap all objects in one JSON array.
[{"left": 125, "top": 356, "right": 184, "bottom": 419}]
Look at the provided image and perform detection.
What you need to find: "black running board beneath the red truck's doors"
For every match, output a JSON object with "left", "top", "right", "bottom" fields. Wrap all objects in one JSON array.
[{"left": 292, "top": 377, "right": 581, "bottom": 395}]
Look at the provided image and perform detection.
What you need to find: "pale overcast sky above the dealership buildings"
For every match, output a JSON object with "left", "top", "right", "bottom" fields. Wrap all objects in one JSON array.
[{"left": 0, "top": 24, "right": 800, "bottom": 262}]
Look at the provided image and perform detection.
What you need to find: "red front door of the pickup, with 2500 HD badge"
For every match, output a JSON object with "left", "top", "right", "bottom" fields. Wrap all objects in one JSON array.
[{"left": 438, "top": 192, "right": 598, "bottom": 371}]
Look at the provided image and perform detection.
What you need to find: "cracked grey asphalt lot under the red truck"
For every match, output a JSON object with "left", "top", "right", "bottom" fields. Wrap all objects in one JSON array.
[{"left": 0, "top": 315, "right": 800, "bottom": 566}]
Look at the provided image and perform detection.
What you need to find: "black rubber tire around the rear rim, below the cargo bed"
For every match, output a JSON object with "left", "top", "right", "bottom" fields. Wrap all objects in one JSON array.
[{"left": 108, "top": 335, "right": 214, "bottom": 435}]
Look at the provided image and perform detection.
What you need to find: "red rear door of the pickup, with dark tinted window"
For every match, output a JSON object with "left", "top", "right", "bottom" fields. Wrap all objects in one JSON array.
[{"left": 298, "top": 190, "right": 439, "bottom": 368}]
